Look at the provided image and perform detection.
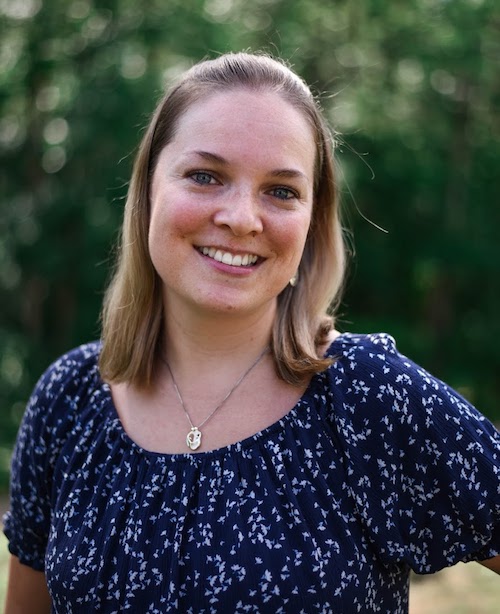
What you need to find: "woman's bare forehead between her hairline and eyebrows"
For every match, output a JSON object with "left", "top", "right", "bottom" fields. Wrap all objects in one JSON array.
[{"left": 167, "top": 88, "right": 316, "bottom": 167}]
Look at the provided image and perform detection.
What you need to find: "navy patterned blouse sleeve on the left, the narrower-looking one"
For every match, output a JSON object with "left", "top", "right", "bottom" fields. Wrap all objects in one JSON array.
[{"left": 4, "top": 344, "right": 99, "bottom": 571}]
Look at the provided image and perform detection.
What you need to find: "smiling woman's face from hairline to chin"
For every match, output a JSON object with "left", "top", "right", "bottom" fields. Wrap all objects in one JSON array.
[{"left": 149, "top": 89, "right": 316, "bottom": 322}]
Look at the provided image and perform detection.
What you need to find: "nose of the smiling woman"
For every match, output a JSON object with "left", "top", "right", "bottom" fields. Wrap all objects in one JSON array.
[{"left": 214, "top": 190, "right": 263, "bottom": 237}]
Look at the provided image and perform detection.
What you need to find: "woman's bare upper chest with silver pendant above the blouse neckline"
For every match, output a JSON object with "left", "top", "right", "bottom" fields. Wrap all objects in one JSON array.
[{"left": 111, "top": 371, "right": 307, "bottom": 454}]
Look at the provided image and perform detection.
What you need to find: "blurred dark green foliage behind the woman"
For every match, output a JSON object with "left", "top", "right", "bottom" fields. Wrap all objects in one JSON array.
[{"left": 0, "top": 0, "right": 500, "bottom": 488}]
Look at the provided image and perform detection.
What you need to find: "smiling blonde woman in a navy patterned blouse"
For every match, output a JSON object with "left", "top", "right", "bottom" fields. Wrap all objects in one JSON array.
[{"left": 5, "top": 54, "right": 500, "bottom": 613}]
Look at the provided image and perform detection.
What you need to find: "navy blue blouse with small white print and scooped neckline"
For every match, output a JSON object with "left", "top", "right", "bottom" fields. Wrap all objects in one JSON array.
[{"left": 5, "top": 334, "right": 500, "bottom": 614}]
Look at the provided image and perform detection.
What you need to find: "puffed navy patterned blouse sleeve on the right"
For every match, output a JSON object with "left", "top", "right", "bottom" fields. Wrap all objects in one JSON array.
[{"left": 331, "top": 335, "right": 500, "bottom": 573}]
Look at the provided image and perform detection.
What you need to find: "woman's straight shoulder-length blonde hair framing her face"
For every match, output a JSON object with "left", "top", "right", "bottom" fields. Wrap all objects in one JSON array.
[{"left": 99, "top": 53, "right": 345, "bottom": 387}]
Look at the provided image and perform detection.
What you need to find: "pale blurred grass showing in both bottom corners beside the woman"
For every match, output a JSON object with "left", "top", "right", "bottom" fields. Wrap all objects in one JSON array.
[{"left": 0, "top": 533, "right": 500, "bottom": 614}]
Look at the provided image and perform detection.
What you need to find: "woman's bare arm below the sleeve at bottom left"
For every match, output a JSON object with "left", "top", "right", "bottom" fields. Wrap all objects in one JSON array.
[{"left": 5, "top": 555, "right": 50, "bottom": 614}]
